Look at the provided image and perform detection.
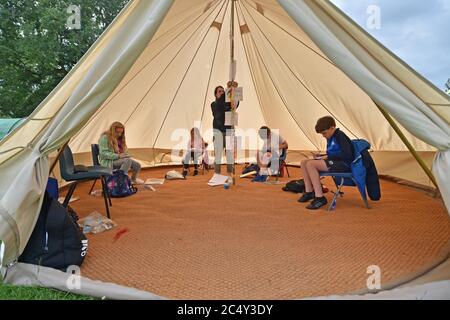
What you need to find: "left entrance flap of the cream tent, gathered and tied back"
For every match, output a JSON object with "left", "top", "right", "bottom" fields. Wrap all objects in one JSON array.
[{"left": 0, "top": 0, "right": 173, "bottom": 265}]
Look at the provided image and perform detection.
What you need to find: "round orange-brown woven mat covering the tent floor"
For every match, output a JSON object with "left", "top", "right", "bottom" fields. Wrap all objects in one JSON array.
[{"left": 67, "top": 168, "right": 450, "bottom": 299}]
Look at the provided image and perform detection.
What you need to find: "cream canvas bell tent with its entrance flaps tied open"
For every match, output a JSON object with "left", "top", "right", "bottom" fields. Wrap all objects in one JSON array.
[{"left": 0, "top": 0, "right": 450, "bottom": 298}]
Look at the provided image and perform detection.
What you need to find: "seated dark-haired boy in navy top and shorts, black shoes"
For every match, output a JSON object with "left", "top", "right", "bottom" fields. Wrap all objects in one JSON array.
[{"left": 298, "top": 117, "right": 353, "bottom": 210}]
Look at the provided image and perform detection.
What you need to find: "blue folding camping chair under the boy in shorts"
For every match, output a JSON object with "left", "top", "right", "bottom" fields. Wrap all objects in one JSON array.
[{"left": 320, "top": 139, "right": 370, "bottom": 211}]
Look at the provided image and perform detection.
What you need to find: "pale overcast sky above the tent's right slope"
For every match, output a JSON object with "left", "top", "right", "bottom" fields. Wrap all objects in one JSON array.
[{"left": 332, "top": 0, "right": 450, "bottom": 89}]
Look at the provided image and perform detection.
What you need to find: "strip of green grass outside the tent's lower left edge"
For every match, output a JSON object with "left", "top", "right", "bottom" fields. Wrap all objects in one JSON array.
[{"left": 0, "top": 283, "right": 96, "bottom": 300}]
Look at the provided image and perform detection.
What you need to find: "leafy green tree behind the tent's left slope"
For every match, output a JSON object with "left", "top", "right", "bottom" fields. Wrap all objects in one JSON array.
[{"left": 0, "top": 0, "right": 128, "bottom": 118}]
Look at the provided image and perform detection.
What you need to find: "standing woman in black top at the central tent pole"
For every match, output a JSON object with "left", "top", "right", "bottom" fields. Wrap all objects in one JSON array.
[{"left": 211, "top": 82, "right": 239, "bottom": 175}]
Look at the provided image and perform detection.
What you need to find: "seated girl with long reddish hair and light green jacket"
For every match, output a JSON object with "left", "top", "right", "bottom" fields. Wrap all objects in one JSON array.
[{"left": 98, "top": 122, "right": 144, "bottom": 184}]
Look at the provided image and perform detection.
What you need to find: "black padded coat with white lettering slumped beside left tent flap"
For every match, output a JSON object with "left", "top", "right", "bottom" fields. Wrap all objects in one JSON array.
[{"left": 19, "top": 192, "right": 88, "bottom": 271}]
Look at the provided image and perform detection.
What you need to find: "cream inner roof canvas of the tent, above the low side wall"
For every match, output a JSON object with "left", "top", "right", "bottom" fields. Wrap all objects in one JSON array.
[{"left": 71, "top": 0, "right": 434, "bottom": 152}]
